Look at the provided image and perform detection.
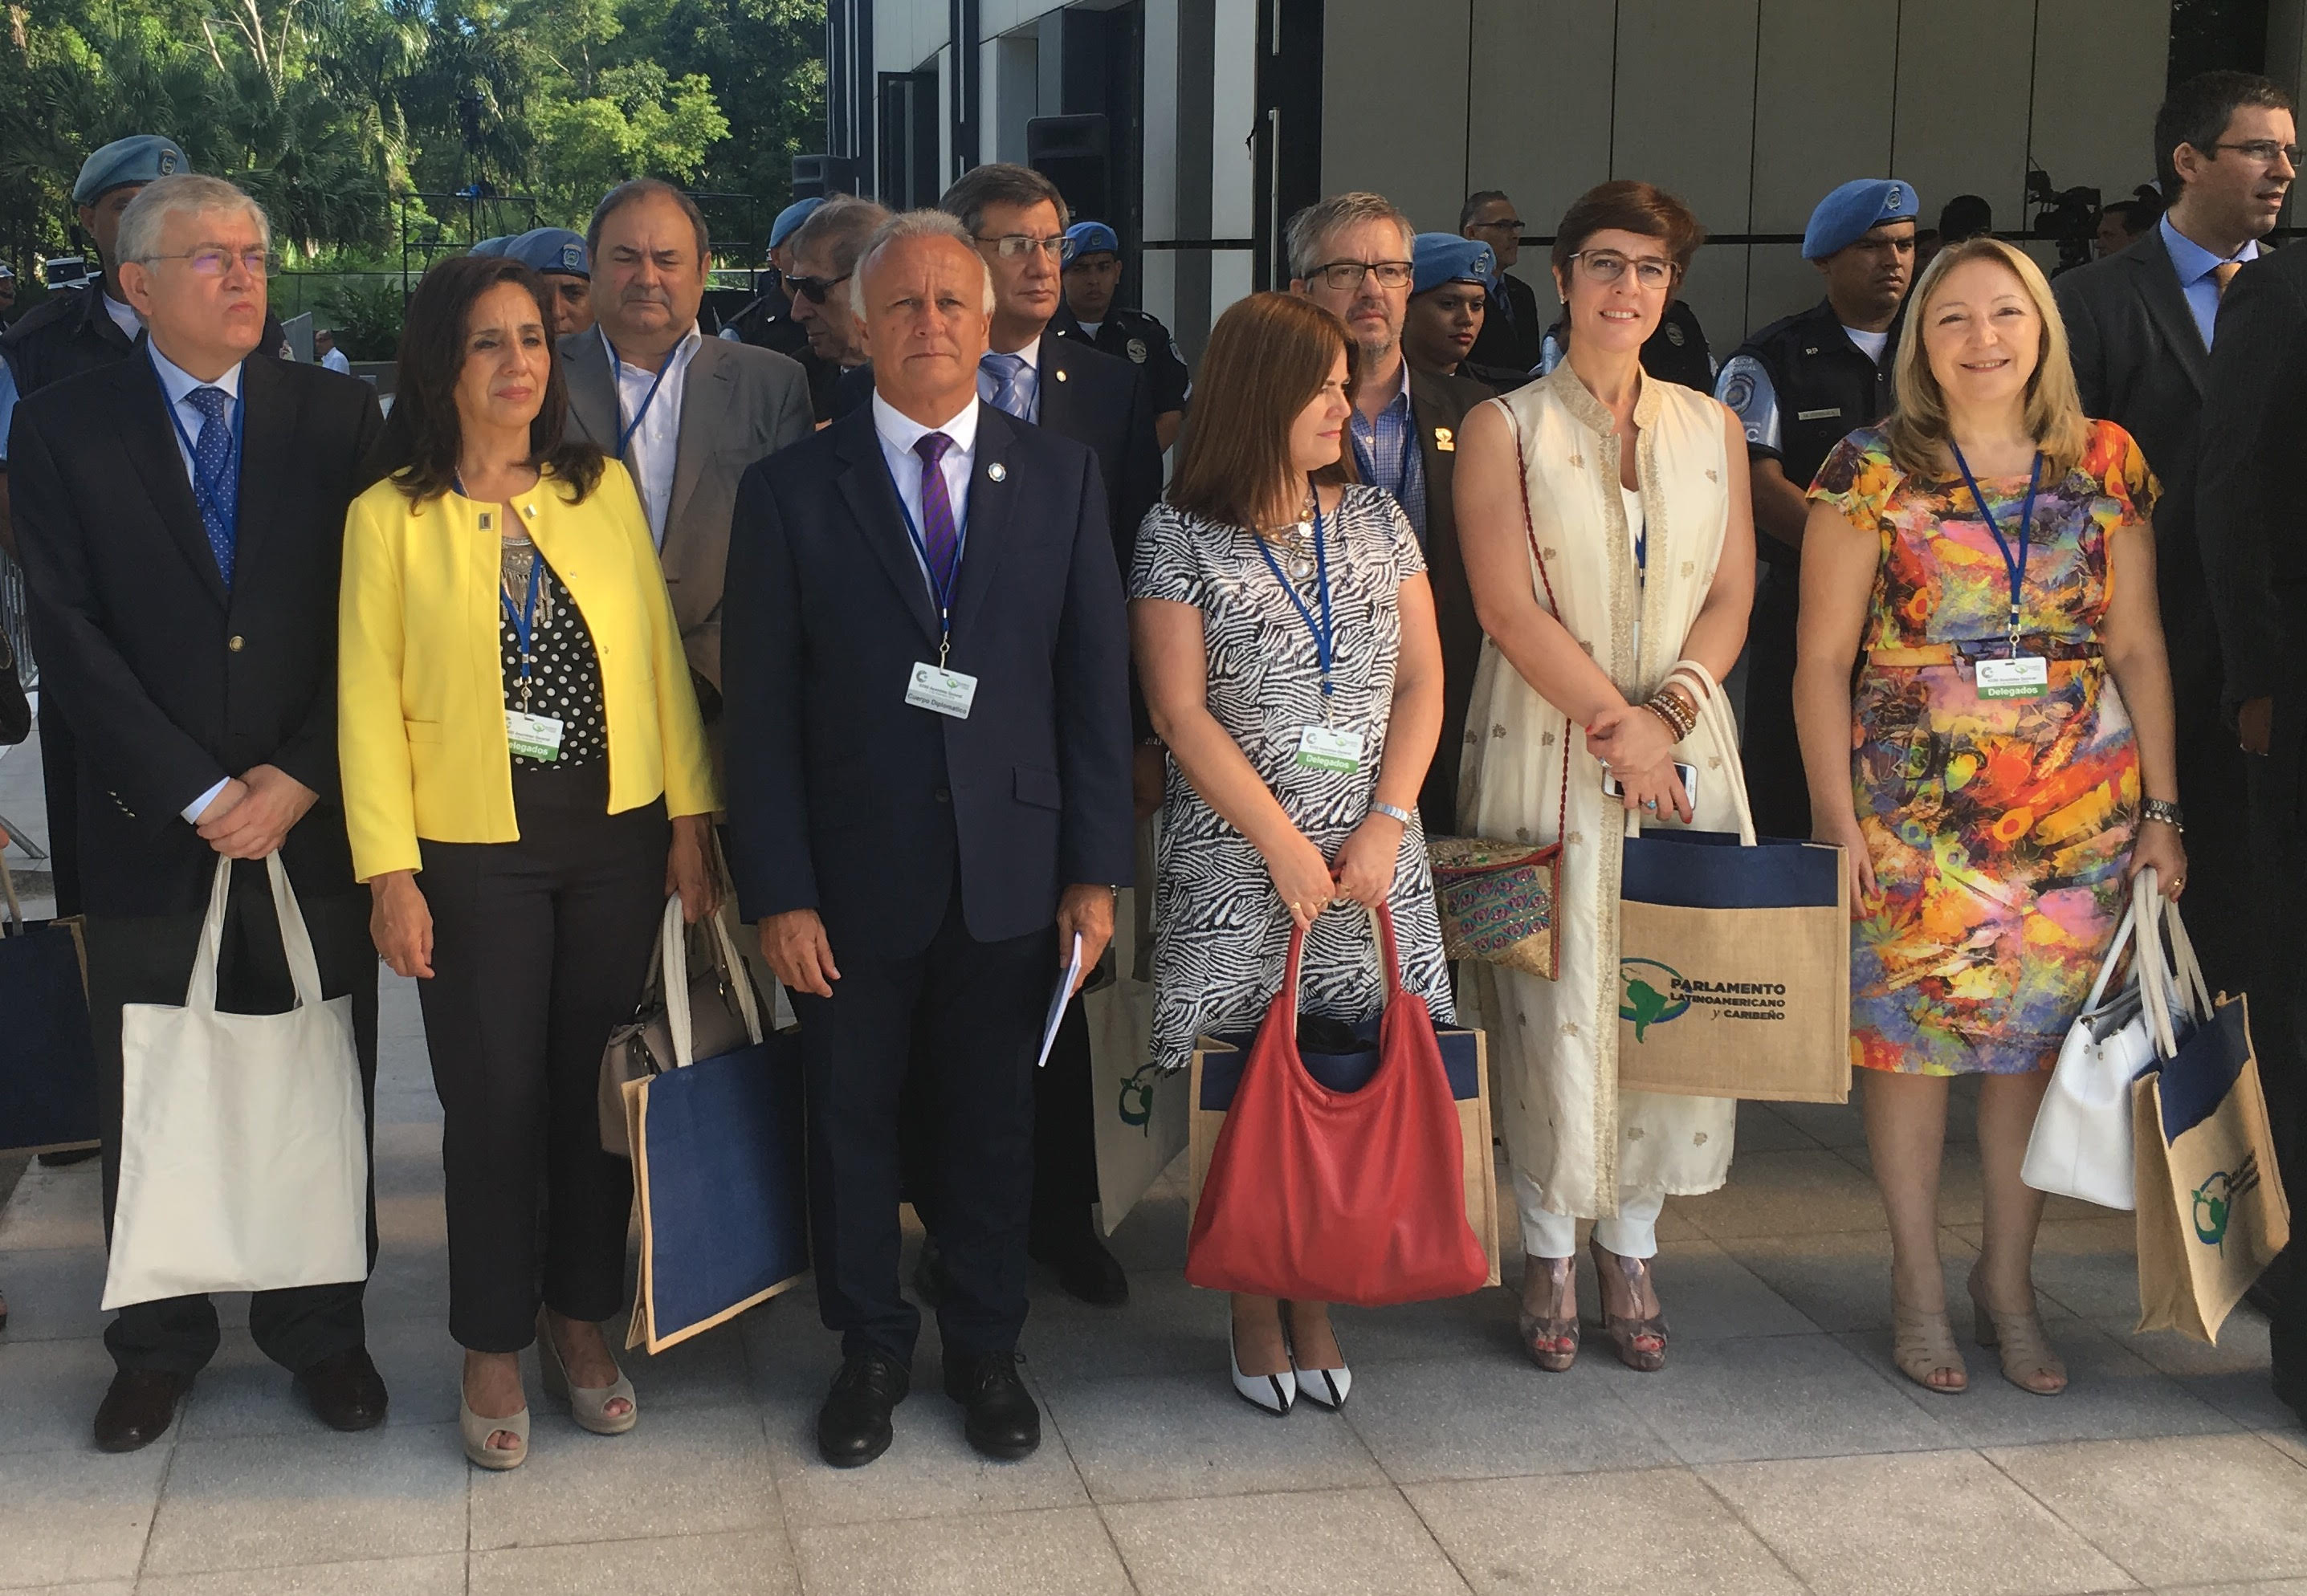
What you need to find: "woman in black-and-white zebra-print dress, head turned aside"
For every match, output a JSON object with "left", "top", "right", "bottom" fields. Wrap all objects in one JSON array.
[{"left": 1131, "top": 293, "right": 1451, "bottom": 1414}]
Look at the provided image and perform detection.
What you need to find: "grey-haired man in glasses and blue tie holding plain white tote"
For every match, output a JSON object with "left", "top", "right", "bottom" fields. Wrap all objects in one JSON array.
[{"left": 9, "top": 175, "right": 385, "bottom": 1451}]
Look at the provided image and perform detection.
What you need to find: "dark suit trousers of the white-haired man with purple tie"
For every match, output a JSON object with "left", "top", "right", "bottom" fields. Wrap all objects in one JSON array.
[{"left": 793, "top": 888, "right": 1047, "bottom": 1363}]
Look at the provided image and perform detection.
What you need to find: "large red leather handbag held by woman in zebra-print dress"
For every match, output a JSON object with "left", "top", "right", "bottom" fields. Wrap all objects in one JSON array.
[{"left": 1186, "top": 909, "right": 1490, "bottom": 1308}]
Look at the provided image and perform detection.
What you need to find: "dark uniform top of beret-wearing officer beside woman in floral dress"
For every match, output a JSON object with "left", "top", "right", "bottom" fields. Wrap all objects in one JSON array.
[{"left": 1714, "top": 299, "right": 1897, "bottom": 503}]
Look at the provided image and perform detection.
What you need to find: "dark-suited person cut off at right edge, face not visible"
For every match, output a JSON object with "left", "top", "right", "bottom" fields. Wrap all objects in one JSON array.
[{"left": 2183, "top": 196, "right": 2307, "bottom": 1423}]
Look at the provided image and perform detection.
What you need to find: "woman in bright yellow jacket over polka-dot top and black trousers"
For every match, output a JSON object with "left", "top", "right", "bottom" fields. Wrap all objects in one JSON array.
[{"left": 336, "top": 259, "right": 718, "bottom": 1469}]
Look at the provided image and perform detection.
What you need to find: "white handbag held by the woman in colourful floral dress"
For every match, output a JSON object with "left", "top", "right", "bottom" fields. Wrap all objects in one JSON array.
[{"left": 2019, "top": 869, "right": 2210, "bottom": 1208}]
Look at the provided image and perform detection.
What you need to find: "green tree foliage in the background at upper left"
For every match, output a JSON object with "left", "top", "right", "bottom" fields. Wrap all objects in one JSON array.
[{"left": 0, "top": 0, "right": 826, "bottom": 265}]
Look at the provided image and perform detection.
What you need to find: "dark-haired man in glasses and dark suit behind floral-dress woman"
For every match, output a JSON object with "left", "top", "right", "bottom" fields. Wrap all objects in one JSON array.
[{"left": 2053, "top": 71, "right": 2296, "bottom": 1024}]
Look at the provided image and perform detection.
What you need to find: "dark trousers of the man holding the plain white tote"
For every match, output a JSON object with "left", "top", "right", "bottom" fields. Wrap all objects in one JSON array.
[{"left": 84, "top": 867, "right": 376, "bottom": 1374}]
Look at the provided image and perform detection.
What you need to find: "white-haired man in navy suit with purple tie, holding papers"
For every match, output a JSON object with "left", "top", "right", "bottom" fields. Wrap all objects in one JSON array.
[{"left": 724, "top": 212, "right": 1133, "bottom": 1467}]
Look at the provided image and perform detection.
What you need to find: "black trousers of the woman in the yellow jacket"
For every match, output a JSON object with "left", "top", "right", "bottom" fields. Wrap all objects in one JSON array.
[{"left": 418, "top": 761, "right": 671, "bottom": 1351}]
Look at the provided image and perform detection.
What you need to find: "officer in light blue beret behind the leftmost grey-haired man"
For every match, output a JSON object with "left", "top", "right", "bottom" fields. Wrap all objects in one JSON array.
[{"left": 0, "top": 134, "right": 288, "bottom": 916}]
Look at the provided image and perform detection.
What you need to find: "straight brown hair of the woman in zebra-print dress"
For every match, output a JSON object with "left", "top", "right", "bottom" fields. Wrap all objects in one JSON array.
[{"left": 1168, "top": 293, "right": 1361, "bottom": 526}]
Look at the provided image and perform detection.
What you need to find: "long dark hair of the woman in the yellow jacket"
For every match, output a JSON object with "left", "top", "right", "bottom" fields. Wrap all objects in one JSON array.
[{"left": 372, "top": 256, "right": 602, "bottom": 505}]
